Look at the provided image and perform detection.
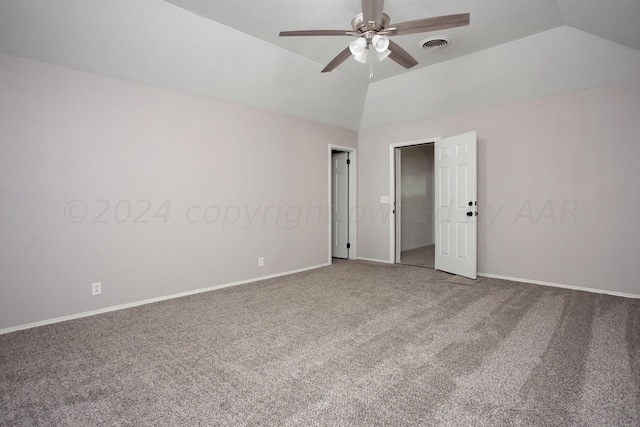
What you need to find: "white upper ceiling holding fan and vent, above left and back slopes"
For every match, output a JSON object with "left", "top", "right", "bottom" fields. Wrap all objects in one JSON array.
[{"left": 165, "top": 0, "right": 640, "bottom": 82}]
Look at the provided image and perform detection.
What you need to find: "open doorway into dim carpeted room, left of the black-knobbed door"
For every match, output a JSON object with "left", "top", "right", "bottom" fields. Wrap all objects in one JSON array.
[{"left": 395, "top": 142, "right": 435, "bottom": 268}]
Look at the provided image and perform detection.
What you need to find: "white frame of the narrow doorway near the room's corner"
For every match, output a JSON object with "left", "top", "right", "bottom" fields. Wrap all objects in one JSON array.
[{"left": 327, "top": 144, "right": 358, "bottom": 264}]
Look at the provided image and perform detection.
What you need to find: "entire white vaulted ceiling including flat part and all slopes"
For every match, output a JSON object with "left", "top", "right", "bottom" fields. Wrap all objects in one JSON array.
[{"left": 0, "top": 0, "right": 640, "bottom": 130}]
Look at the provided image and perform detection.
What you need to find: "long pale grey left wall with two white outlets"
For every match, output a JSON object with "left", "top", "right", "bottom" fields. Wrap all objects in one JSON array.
[{"left": 0, "top": 51, "right": 357, "bottom": 330}]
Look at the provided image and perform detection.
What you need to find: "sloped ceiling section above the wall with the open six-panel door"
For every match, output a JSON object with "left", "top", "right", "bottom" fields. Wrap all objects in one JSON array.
[{"left": 360, "top": 26, "right": 640, "bottom": 130}]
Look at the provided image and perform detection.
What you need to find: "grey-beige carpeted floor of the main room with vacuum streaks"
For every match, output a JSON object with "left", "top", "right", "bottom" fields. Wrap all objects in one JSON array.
[{"left": 0, "top": 261, "right": 640, "bottom": 426}]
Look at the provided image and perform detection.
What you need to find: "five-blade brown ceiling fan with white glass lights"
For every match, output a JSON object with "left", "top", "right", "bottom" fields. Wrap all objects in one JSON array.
[{"left": 280, "top": 0, "right": 469, "bottom": 77}]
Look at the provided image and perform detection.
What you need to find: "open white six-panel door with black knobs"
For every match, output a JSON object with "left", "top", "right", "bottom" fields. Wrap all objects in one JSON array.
[{"left": 435, "top": 132, "right": 478, "bottom": 279}]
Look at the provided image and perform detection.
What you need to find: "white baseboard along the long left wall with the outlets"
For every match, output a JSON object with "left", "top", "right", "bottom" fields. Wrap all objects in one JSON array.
[{"left": 0, "top": 264, "right": 329, "bottom": 335}]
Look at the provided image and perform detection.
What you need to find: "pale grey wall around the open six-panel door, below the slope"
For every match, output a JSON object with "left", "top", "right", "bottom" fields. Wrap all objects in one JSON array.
[{"left": 358, "top": 82, "right": 640, "bottom": 295}]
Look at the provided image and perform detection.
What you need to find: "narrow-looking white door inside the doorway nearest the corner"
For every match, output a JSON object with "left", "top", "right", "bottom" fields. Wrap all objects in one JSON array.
[{"left": 331, "top": 152, "right": 349, "bottom": 258}]
